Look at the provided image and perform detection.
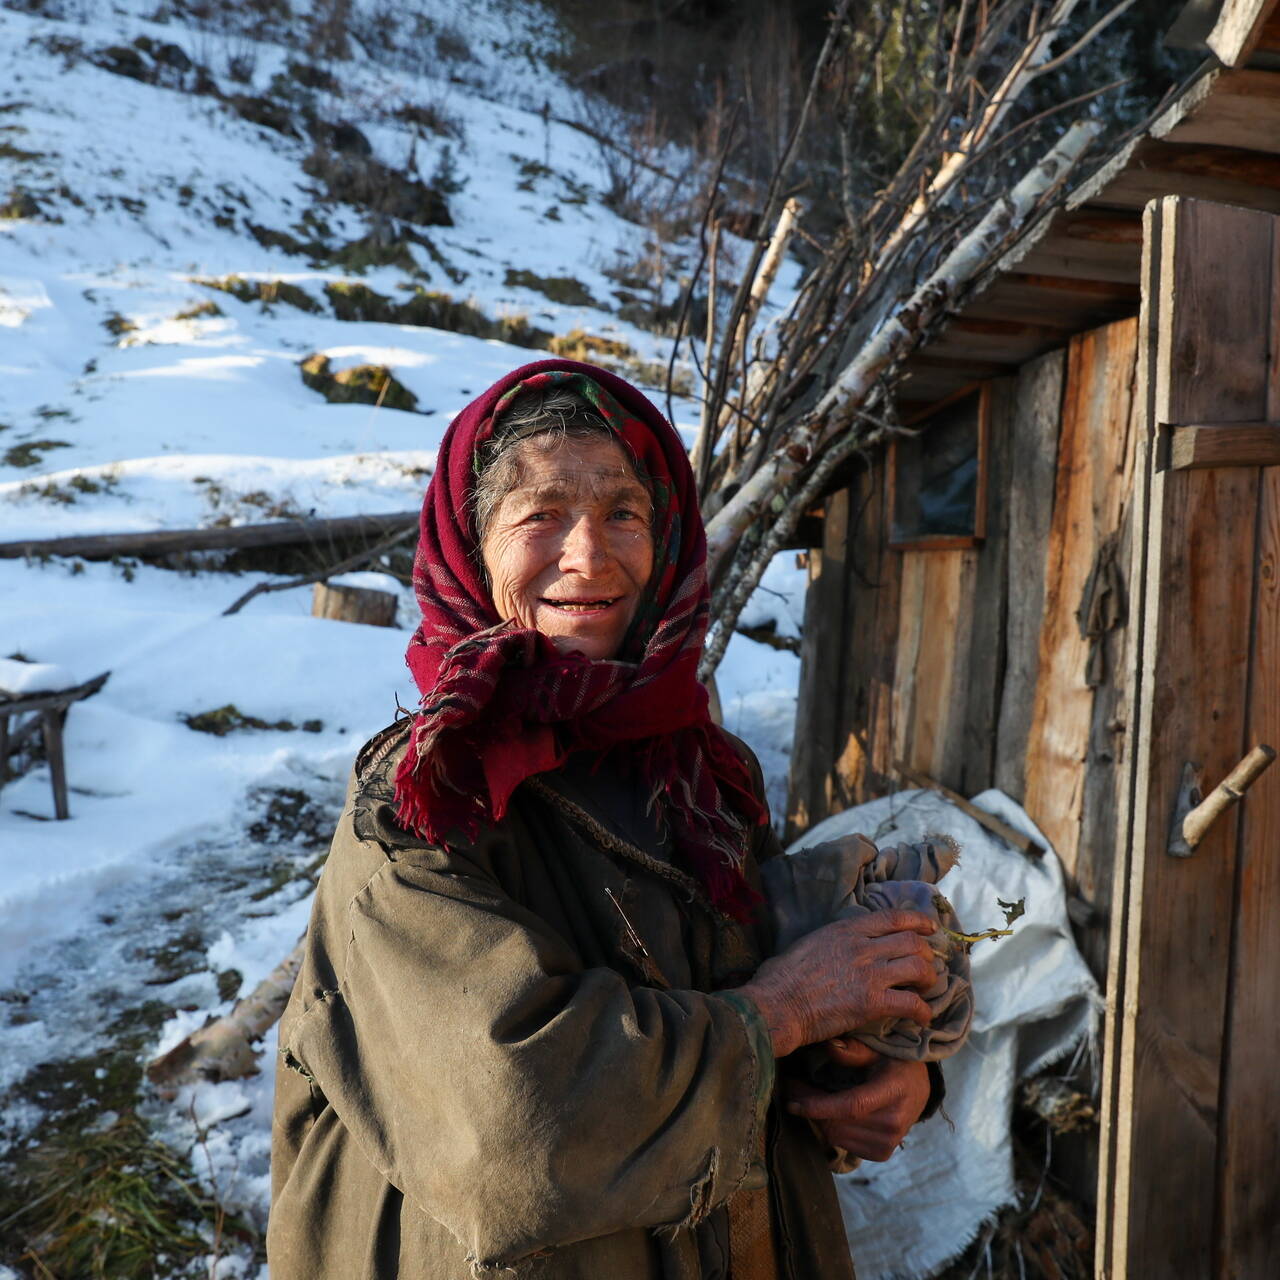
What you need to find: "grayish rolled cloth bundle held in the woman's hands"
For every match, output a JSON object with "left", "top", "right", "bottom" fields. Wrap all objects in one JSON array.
[{"left": 760, "top": 835, "right": 973, "bottom": 1059}]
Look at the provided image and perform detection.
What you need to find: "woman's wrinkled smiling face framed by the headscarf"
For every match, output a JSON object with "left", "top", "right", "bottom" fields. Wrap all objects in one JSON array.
[{"left": 481, "top": 436, "right": 653, "bottom": 658}]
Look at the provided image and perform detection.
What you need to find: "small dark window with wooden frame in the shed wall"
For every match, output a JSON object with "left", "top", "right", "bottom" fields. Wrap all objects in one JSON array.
[{"left": 890, "top": 383, "right": 988, "bottom": 549}]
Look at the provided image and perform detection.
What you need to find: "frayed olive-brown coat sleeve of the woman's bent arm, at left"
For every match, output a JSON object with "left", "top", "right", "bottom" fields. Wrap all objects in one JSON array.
[{"left": 282, "top": 809, "right": 773, "bottom": 1270}]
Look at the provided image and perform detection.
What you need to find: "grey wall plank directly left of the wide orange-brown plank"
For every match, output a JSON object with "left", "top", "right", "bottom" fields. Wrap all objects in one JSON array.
[{"left": 996, "top": 349, "right": 1066, "bottom": 801}]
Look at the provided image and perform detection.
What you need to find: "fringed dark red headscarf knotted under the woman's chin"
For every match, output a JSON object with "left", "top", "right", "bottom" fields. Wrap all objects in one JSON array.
[{"left": 396, "top": 360, "right": 765, "bottom": 919}]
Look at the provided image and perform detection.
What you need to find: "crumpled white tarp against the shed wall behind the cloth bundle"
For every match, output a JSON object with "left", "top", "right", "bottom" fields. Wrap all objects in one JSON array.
[{"left": 792, "top": 790, "right": 1102, "bottom": 1280}]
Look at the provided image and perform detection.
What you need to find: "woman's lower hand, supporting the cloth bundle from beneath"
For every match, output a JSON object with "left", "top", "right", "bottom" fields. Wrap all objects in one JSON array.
[{"left": 787, "top": 1041, "right": 929, "bottom": 1161}]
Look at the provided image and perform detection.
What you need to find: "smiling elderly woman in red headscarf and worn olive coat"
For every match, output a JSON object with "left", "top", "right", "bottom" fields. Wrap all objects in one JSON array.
[{"left": 268, "top": 361, "right": 936, "bottom": 1280}]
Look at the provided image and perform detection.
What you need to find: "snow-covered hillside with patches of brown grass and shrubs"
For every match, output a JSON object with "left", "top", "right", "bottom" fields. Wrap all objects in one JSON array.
[{"left": 0, "top": 0, "right": 803, "bottom": 1276}]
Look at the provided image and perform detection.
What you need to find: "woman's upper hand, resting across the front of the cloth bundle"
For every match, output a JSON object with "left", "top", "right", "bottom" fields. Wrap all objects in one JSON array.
[{"left": 739, "top": 911, "right": 938, "bottom": 1057}]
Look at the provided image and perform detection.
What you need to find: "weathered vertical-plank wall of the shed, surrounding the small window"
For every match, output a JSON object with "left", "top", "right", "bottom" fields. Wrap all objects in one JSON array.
[{"left": 788, "top": 320, "right": 1137, "bottom": 982}]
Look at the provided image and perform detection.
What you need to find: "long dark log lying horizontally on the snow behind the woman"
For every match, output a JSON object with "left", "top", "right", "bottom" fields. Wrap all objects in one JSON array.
[{"left": 0, "top": 511, "right": 419, "bottom": 559}]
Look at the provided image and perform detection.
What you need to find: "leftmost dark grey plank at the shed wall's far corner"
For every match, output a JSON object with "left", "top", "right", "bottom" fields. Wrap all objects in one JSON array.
[{"left": 786, "top": 489, "right": 849, "bottom": 840}]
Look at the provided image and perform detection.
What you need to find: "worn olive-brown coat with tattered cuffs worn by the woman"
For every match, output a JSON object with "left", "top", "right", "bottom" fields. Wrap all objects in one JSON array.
[{"left": 268, "top": 726, "right": 852, "bottom": 1280}]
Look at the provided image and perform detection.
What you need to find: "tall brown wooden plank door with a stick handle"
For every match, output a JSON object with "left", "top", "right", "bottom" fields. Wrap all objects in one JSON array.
[{"left": 1097, "top": 197, "right": 1280, "bottom": 1280}]
